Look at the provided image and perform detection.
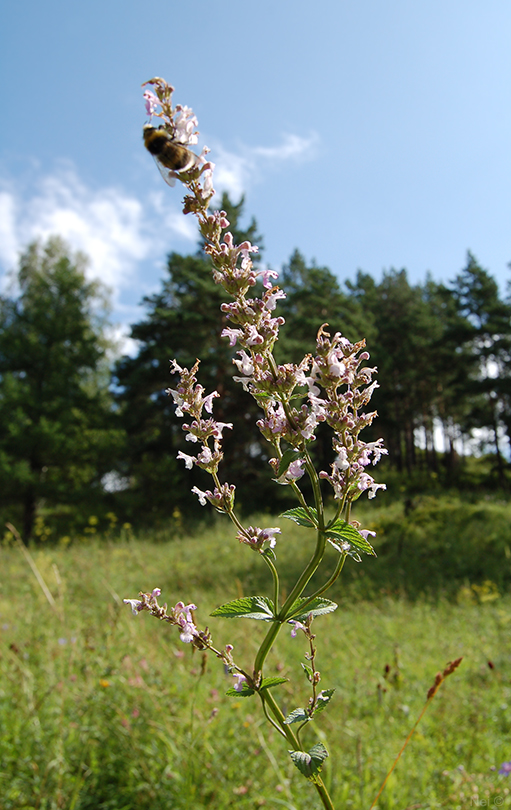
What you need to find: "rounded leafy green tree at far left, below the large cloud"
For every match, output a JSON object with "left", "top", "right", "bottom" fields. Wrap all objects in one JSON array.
[{"left": 0, "top": 238, "right": 122, "bottom": 539}]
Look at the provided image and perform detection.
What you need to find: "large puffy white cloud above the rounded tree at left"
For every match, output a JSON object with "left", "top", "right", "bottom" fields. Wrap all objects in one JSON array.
[{"left": 0, "top": 167, "right": 197, "bottom": 305}]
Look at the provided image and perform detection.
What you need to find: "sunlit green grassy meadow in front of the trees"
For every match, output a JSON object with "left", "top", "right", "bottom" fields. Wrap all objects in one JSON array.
[{"left": 0, "top": 492, "right": 511, "bottom": 810}]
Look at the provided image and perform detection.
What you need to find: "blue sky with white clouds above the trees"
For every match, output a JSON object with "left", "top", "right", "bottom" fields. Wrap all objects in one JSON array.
[{"left": 0, "top": 0, "right": 511, "bottom": 344}]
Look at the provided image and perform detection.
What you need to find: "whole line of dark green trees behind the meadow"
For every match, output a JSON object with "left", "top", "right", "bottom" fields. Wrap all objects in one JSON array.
[{"left": 0, "top": 195, "right": 511, "bottom": 539}]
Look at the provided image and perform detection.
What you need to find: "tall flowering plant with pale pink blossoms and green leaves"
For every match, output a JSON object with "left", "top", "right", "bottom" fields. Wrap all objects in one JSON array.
[{"left": 124, "top": 78, "right": 387, "bottom": 810}]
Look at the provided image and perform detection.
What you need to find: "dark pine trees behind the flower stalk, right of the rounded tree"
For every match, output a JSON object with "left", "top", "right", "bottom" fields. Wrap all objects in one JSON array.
[{"left": 113, "top": 230, "right": 511, "bottom": 532}]
